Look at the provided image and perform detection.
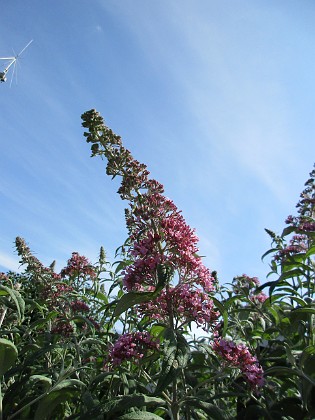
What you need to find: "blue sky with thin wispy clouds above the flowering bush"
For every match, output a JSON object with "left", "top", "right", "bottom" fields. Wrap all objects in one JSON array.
[{"left": 0, "top": 0, "right": 315, "bottom": 282}]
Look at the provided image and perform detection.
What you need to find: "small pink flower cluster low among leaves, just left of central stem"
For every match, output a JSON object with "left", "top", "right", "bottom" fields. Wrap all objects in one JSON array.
[{"left": 109, "top": 332, "right": 159, "bottom": 366}]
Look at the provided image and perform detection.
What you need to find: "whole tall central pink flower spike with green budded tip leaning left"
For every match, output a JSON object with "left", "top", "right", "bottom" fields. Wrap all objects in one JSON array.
[{"left": 82, "top": 110, "right": 216, "bottom": 325}]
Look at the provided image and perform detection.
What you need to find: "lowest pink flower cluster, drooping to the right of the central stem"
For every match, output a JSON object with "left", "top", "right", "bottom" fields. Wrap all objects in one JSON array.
[{"left": 212, "top": 338, "right": 265, "bottom": 390}]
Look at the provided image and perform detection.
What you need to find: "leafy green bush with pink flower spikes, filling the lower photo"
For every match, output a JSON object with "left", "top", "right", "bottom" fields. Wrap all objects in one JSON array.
[{"left": 0, "top": 110, "right": 315, "bottom": 420}]
